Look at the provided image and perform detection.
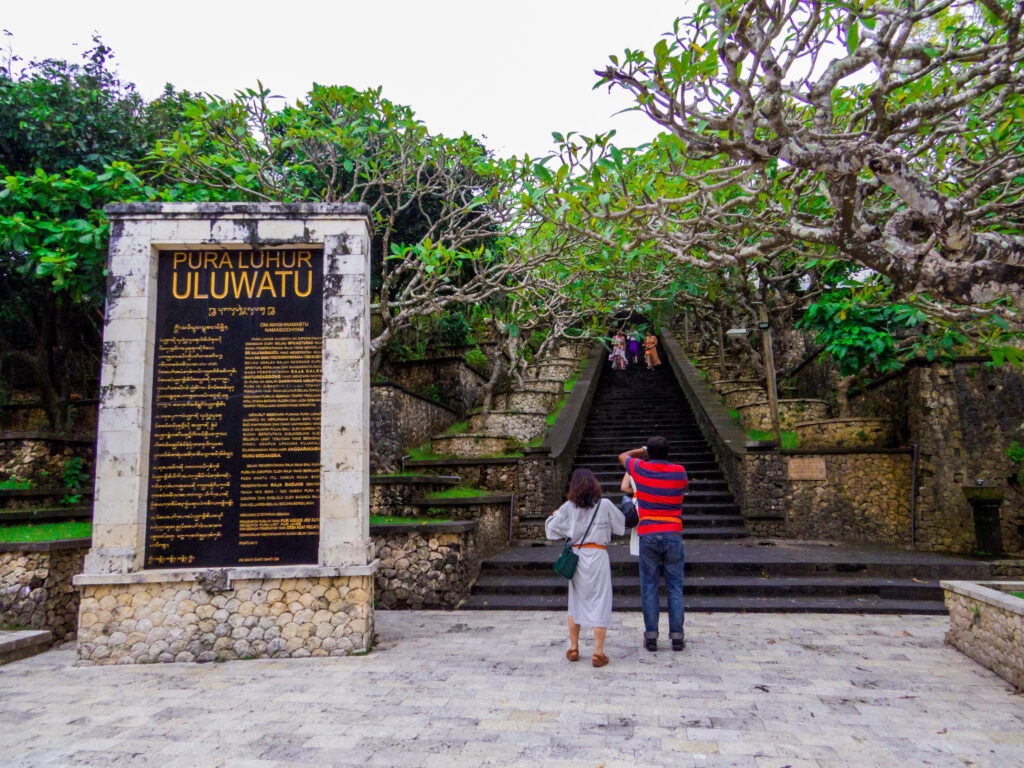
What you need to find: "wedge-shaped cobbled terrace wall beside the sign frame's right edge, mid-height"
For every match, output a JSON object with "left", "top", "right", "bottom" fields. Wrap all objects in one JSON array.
[{"left": 370, "top": 384, "right": 458, "bottom": 473}]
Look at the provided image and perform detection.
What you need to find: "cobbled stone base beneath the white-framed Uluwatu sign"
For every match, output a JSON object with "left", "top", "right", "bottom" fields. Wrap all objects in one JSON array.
[{"left": 78, "top": 575, "right": 374, "bottom": 665}]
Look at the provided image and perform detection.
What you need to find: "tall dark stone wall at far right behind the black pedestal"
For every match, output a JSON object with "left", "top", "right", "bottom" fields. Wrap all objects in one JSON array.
[{"left": 853, "top": 362, "right": 1024, "bottom": 552}]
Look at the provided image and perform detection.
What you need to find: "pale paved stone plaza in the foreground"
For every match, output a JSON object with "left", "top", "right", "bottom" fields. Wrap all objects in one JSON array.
[{"left": 0, "top": 611, "right": 1024, "bottom": 768}]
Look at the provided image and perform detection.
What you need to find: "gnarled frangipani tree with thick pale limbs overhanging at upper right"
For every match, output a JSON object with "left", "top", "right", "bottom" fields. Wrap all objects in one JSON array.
[{"left": 598, "top": 0, "right": 1024, "bottom": 322}]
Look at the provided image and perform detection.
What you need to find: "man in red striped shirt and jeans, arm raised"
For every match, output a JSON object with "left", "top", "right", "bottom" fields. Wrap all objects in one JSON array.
[{"left": 618, "top": 437, "right": 687, "bottom": 651}]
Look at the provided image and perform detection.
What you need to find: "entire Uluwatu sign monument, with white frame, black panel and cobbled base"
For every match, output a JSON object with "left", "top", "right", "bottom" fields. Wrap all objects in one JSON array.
[{"left": 75, "top": 204, "right": 376, "bottom": 664}]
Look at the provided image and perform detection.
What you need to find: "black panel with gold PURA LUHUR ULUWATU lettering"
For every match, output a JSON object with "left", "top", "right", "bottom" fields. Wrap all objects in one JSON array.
[{"left": 145, "top": 246, "right": 324, "bottom": 568}]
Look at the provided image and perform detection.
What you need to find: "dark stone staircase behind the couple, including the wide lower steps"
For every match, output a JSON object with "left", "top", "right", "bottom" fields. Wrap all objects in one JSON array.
[{"left": 462, "top": 348, "right": 991, "bottom": 614}]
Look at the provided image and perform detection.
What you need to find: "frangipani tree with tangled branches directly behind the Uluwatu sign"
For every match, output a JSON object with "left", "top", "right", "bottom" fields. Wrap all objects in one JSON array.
[{"left": 154, "top": 85, "right": 551, "bottom": 364}]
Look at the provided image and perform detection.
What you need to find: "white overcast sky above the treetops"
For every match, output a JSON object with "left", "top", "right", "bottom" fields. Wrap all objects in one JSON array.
[{"left": 0, "top": 0, "right": 691, "bottom": 156}]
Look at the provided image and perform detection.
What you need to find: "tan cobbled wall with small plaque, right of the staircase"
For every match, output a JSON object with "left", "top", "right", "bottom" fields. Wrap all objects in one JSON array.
[{"left": 783, "top": 454, "right": 911, "bottom": 547}]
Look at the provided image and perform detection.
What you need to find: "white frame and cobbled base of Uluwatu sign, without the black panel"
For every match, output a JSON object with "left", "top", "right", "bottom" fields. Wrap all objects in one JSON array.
[{"left": 76, "top": 203, "right": 376, "bottom": 664}]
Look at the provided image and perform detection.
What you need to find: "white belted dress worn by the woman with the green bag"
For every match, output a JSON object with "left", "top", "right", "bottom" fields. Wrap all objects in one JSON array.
[{"left": 544, "top": 499, "right": 626, "bottom": 627}]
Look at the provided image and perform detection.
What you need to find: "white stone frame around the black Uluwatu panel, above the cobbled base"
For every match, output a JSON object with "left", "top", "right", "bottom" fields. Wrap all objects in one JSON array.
[{"left": 76, "top": 203, "right": 376, "bottom": 585}]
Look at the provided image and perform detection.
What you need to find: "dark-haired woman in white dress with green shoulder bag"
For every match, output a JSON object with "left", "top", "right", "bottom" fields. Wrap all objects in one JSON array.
[{"left": 544, "top": 469, "right": 626, "bottom": 667}]
